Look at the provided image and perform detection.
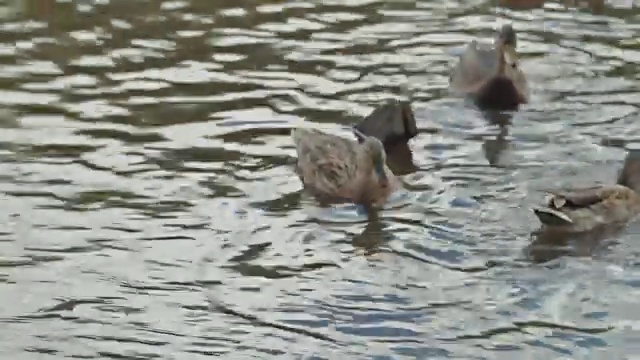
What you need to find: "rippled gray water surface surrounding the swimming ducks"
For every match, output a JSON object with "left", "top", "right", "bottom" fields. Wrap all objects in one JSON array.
[{"left": 0, "top": 0, "right": 640, "bottom": 359}]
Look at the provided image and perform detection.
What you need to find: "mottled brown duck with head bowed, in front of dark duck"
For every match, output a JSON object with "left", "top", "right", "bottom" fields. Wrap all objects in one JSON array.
[{"left": 291, "top": 128, "right": 399, "bottom": 207}]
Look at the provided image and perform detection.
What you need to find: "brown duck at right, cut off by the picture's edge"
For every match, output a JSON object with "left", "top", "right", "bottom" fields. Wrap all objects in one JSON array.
[{"left": 533, "top": 151, "right": 640, "bottom": 233}]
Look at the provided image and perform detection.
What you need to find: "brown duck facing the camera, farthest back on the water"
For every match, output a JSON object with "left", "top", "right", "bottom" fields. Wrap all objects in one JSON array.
[{"left": 449, "top": 24, "right": 529, "bottom": 109}]
